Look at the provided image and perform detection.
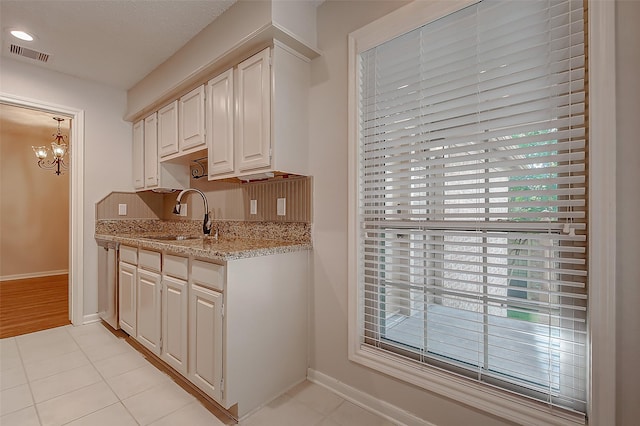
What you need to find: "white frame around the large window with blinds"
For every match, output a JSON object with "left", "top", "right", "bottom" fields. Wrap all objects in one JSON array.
[{"left": 348, "top": 0, "right": 616, "bottom": 425}]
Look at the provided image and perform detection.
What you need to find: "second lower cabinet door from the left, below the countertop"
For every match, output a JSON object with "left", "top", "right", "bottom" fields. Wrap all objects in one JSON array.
[{"left": 136, "top": 269, "right": 162, "bottom": 356}]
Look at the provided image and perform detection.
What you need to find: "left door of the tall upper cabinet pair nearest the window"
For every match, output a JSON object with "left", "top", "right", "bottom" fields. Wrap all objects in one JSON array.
[{"left": 205, "top": 69, "right": 233, "bottom": 179}]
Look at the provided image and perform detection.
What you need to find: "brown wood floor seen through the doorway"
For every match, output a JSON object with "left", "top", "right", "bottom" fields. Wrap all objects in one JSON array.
[{"left": 0, "top": 274, "right": 71, "bottom": 339}]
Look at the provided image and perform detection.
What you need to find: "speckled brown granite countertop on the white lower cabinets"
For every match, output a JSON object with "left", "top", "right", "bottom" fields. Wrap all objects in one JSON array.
[{"left": 95, "top": 233, "right": 311, "bottom": 261}]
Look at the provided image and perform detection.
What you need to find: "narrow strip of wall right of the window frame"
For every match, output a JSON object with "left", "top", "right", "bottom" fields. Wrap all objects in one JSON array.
[{"left": 616, "top": 0, "right": 640, "bottom": 426}]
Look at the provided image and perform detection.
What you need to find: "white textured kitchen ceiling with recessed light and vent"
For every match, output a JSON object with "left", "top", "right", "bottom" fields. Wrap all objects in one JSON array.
[{"left": 0, "top": 0, "right": 236, "bottom": 90}]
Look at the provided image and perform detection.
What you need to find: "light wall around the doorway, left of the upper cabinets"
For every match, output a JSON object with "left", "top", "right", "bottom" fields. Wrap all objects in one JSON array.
[{"left": 0, "top": 58, "right": 133, "bottom": 316}]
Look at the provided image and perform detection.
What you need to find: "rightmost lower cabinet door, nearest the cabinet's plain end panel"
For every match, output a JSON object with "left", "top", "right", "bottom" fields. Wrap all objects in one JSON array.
[{"left": 189, "top": 284, "right": 223, "bottom": 402}]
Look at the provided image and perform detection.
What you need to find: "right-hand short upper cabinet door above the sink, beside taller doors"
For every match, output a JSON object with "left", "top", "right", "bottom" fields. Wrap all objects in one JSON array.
[{"left": 178, "top": 86, "right": 205, "bottom": 151}]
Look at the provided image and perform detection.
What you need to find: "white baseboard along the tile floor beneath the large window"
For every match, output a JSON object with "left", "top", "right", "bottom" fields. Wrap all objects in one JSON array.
[{"left": 307, "top": 368, "right": 436, "bottom": 426}]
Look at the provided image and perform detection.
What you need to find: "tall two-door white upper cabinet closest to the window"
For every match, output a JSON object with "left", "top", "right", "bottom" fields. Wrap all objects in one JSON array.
[{"left": 206, "top": 42, "right": 309, "bottom": 180}]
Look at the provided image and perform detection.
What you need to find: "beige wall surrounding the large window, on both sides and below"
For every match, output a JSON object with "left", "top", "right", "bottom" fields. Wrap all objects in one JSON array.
[{"left": 309, "top": 0, "right": 640, "bottom": 426}]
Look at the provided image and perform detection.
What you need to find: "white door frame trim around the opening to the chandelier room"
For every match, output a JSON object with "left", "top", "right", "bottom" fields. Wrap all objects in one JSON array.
[{"left": 0, "top": 92, "right": 84, "bottom": 325}]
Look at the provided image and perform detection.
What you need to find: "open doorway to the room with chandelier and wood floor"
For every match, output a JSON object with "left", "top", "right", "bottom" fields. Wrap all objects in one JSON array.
[{"left": 0, "top": 104, "right": 70, "bottom": 338}]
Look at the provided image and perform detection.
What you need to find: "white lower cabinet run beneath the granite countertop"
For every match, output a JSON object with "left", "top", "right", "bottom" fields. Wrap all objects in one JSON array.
[{"left": 119, "top": 246, "right": 308, "bottom": 418}]
